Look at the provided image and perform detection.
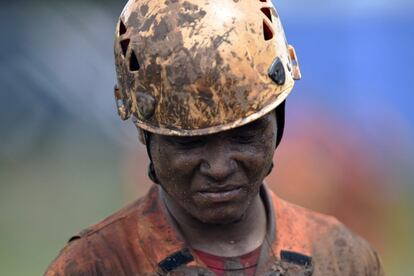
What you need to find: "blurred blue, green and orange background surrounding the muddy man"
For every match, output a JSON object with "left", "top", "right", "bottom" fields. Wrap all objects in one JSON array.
[{"left": 0, "top": 0, "right": 414, "bottom": 276}]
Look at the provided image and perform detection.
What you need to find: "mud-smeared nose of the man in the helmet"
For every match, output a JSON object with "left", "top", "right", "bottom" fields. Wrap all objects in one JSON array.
[{"left": 200, "top": 145, "right": 237, "bottom": 182}]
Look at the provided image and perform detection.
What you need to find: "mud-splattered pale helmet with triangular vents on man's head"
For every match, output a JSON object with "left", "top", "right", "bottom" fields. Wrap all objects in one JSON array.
[{"left": 115, "top": 0, "right": 300, "bottom": 136}]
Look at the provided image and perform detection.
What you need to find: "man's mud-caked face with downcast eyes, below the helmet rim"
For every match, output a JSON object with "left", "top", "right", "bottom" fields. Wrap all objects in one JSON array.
[{"left": 150, "top": 112, "right": 276, "bottom": 224}]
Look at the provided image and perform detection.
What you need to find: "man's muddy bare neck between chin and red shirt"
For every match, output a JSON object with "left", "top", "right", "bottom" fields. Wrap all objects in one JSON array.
[{"left": 161, "top": 189, "right": 266, "bottom": 257}]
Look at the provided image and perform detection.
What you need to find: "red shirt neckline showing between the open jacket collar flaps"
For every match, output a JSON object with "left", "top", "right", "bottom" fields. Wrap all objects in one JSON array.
[{"left": 193, "top": 247, "right": 261, "bottom": 276}]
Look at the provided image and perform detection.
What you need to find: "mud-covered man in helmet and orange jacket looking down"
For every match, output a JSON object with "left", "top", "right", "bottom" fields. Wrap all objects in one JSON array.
[{"left": 45, "top": 0, "right": 383, "bottom": 276}]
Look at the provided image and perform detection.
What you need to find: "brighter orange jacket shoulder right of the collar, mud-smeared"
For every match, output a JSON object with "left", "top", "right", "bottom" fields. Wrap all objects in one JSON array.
[{"left": 273, "top": 191, "right": 384, "bottom": 275}]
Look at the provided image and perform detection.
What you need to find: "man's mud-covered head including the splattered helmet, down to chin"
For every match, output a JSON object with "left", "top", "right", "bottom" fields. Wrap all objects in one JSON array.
[{"left": 115, "top": 0, "right": 300, "bottom": 223}]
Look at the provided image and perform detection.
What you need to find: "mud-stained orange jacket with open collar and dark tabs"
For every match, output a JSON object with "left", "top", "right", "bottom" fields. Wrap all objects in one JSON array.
[{"left": 45, "top": 186, "right": 384, "bottom": 276}]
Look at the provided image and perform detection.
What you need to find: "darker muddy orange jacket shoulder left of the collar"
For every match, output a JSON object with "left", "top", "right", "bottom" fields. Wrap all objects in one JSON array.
[{"left": 45, "top": 196, "right": 148, "bottom": 276}]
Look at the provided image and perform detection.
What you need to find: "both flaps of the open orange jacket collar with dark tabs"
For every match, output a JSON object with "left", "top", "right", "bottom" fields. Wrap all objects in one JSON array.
[{"left": 137, "top": 185, "right": 311, "bottom": 275}]
